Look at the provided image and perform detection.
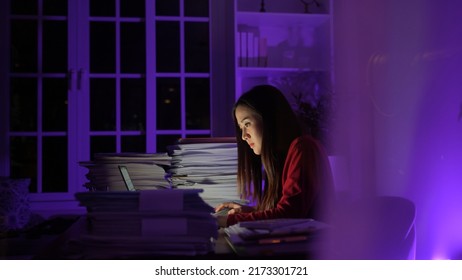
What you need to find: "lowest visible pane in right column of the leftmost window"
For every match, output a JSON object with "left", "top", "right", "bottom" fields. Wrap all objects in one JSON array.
[{"left": 42, "top": 137, "right": 68, "bottom": 192}]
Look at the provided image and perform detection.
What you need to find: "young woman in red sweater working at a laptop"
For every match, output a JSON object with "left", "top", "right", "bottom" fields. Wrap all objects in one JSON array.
[{"left": 215, "top": 85, "right": 333, "bottom": 227}]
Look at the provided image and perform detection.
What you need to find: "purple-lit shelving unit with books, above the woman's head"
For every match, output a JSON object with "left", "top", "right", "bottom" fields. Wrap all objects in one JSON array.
[{"left": 234, "top": 0, "right": 332, "bottom": 98}]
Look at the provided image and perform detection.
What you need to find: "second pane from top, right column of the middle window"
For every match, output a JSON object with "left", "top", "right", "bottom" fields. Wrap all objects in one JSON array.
[{"left": 120, "top": 22, "right": 146, "bottom": 73}]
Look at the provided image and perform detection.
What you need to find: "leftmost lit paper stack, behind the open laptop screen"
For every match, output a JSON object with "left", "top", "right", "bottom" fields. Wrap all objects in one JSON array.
[{"left": 80, "top": 153, "right": 171, "bottom": 191}]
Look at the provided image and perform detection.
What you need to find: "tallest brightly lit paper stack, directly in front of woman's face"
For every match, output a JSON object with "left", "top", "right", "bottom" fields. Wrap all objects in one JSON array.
[{"left": 167, "top": 137, "right": 244, "bottom": 206}]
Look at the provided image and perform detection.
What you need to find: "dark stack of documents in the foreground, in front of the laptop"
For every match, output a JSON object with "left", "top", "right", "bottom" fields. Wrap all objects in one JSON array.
[{"left": 74, "top": 189, "right": 218, "bottom": 259}]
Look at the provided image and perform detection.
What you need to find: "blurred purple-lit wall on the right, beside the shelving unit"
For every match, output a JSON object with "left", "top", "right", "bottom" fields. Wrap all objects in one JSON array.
[{"left": 334, "top": 0, "right": 462, "bottom": 259}]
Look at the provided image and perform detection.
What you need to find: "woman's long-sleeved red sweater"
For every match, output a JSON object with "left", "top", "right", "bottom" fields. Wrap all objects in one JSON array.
[{"left": 227, "top": 136, "right": 333, "bottom": 226}]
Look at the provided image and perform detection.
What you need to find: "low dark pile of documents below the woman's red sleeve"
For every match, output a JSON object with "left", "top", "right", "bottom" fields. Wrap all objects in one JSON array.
[{"left": 225, "top": 218, "right": 329, "bottom": 258}]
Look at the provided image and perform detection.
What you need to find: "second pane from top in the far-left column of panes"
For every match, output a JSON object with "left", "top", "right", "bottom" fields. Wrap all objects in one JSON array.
[{"left": 11, "top": 20, "right": 37, "bottom": 72}]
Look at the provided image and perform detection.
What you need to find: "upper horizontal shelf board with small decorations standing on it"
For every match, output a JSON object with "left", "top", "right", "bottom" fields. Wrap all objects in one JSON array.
[{"left": 236, "top": 12, "right": 330, "bottom": 27}]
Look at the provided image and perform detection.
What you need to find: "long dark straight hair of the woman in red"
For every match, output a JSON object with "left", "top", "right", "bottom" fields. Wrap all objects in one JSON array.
[{"left": 233, "top": 85, "right": 302, "bottom": 210}]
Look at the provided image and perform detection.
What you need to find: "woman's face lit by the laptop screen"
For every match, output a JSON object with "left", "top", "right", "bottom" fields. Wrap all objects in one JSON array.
[{"left": 235, "top": 105, "right": 263, "bottom": 155}]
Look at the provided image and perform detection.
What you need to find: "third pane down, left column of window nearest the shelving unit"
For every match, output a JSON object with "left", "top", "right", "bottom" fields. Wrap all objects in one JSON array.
[{"left": 156, "top": 78, "right": 181, "bottom": 129}]
